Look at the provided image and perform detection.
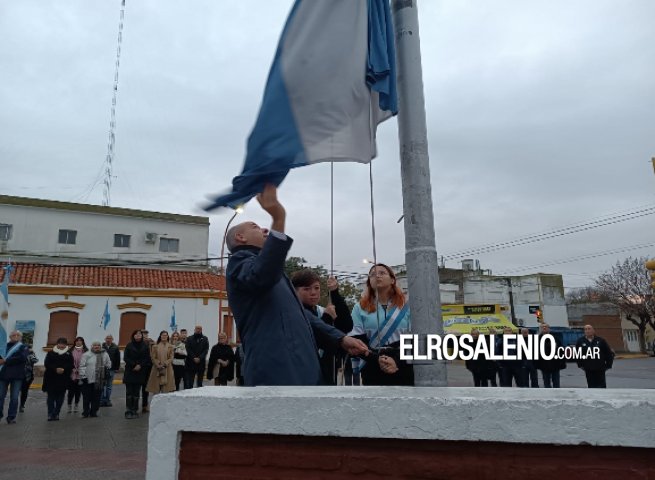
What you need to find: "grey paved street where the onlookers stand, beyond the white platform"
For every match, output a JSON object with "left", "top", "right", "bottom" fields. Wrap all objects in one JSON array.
[{"left": 0, "top": 358, "right": 655, "bottom": 480}]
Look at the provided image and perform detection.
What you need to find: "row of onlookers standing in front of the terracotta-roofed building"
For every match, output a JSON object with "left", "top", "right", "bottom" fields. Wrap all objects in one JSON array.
[{"left": 0, "top": 326, "right": 244, "bottom": 424}]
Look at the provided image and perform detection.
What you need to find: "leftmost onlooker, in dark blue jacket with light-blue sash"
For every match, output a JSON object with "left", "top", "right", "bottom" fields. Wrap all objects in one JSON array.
[{"left": 0, "top": 330, "right": 28, "bottom": 424}]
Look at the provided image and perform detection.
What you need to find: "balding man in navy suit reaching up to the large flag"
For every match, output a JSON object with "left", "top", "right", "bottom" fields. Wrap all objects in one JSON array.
[{"left": 226, "top": 185, "right": 368, "bottom": 386}]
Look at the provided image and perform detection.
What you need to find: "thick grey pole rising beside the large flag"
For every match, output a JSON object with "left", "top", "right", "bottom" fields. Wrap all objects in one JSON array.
[{"left": 391, "top": 0, "right": 448, "bottom": 387}]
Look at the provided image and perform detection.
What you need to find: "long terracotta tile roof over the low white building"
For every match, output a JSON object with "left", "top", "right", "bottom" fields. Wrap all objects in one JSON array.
[{"left": 0, "top": 263, "right": 225, "bottom": 291}]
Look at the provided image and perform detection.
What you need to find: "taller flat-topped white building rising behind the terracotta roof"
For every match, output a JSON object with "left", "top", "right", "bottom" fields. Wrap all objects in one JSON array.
[{"left": 0, "top": 195, "right": 209, "bottom": 269}]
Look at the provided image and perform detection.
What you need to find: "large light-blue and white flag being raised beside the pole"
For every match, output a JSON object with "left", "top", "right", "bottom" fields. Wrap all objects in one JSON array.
[{"left": 206, "top": 0, "right": 398, "bottom": 210}]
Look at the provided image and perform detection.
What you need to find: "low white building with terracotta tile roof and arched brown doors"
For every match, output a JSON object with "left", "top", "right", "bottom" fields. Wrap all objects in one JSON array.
[{"left": 0, "top": 263, "right": 225, "bottom": 363}]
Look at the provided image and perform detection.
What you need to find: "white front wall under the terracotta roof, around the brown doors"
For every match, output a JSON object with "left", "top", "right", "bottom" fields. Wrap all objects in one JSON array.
[{"left": 8, "top": 294, "right": 218, "bottom": 364}]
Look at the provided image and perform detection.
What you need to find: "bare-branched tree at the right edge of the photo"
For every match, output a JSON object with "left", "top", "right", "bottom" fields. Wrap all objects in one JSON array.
[{"left": 596, "top": 257, "right": 655, "bottom": 353}]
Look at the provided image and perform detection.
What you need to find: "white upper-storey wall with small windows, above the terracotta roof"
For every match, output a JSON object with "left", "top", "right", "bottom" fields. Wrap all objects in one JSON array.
[{"left": 0, "top": 205, "right": 209, "bottom": 263}]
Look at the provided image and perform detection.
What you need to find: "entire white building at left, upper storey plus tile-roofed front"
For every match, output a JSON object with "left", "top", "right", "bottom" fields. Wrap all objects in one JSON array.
[{"left": 0, "top": 195, "right": 236, "bottom": 360}]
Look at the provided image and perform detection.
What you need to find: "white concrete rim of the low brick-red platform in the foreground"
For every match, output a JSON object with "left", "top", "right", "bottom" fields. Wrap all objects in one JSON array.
[{"left": 147, "top": 387, "right": 655, "bottom": 480}]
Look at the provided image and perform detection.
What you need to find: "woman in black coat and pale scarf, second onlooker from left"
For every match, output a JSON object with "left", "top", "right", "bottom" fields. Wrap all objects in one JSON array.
[{"left": 41, "top": 337, "right": 73, "bottom": 422}]
